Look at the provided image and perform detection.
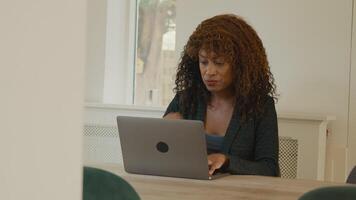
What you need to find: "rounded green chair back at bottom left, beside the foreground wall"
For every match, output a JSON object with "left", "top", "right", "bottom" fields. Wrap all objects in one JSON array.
[{"left": 83, "top": 167, "right": 140, "bottom": 200}]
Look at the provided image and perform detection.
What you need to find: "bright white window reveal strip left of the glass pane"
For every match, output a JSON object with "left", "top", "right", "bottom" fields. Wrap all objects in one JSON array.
[{"left": 103, "top": 0, "right": 135, "bottom": 104}]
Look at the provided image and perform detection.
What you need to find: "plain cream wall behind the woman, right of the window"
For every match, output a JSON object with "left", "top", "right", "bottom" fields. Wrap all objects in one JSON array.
[{"left": 177, "top": 0, "right": 352, "bottom": 180}]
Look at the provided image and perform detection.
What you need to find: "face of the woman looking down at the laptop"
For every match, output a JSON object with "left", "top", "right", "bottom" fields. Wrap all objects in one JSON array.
[{"left": 199, "top": 50, "right": 233, "bottom": 93}]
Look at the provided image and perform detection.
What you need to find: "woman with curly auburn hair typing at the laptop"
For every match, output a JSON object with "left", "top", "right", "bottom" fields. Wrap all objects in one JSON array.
[{"left": 164, "top": 14, "right": 280, "bottom": 176}]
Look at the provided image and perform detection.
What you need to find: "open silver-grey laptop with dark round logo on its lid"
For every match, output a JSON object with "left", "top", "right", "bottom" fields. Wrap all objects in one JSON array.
[{"left": 117, "top": 116, "right": 228, "bottom": 179}]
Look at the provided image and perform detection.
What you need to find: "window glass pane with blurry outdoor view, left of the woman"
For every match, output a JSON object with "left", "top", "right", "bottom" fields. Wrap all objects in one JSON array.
[{"left": 134, "top": 0, "right": 177, "bottom": 106}]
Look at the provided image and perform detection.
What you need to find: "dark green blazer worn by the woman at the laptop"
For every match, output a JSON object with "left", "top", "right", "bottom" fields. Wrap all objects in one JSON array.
[{"left": 164, "top": 95, "right": 280, "bottom": 176}]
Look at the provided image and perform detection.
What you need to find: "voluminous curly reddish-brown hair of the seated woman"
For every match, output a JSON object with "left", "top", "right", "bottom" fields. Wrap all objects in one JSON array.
[{"left": 174, "top": 14, "right": 277, "bottom": 119}]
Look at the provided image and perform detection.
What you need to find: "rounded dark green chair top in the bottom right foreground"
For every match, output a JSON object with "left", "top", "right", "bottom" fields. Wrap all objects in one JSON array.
[{"left": 299, "top": 186, "right": 356, "bottom": 200}]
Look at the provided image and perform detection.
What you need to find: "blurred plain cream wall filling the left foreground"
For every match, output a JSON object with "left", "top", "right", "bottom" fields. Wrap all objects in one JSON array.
[{"left": 0, "top": 0, "right": 86, "bottom": 200}]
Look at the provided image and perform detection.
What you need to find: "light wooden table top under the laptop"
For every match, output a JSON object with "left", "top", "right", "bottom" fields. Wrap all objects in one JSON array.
[{"left": 90, "top": 165, "right": 343, "bottom": 200}]
